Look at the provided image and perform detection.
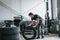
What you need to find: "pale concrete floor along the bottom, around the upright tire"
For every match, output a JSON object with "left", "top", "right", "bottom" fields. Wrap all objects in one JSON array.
[{"left": 20, "top": 34, "right": 60, "bottom": 40}]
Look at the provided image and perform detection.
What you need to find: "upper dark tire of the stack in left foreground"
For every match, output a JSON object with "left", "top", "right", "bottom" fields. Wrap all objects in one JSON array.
[{"left": 1, "top": 27, "right": 20, "bottom": 35}]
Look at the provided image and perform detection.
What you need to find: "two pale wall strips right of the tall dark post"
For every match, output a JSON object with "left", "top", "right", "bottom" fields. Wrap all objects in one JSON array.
[{"left": 48, "top": 0, "right": 57, "bottom": 19}]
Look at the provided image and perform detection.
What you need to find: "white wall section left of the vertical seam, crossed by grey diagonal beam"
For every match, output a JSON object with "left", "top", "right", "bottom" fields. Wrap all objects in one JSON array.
[{"left": 0, "top": 0, "right": 20, "bottom": 20}]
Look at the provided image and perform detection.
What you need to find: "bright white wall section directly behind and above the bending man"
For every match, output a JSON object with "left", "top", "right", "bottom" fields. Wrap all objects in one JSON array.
[{"left": 21, "top": 0, "right": 46, "bottom": 19}]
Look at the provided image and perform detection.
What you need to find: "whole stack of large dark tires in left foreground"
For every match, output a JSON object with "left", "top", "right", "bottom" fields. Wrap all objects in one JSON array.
[{"left": 0, "top": 27, "right": 20, "bottom": 40}]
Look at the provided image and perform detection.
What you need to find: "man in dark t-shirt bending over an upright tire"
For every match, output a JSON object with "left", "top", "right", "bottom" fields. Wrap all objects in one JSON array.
[{"left": 28, "top": 12, "right": 43, "bottom": 38}]
